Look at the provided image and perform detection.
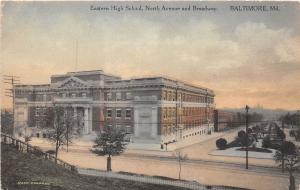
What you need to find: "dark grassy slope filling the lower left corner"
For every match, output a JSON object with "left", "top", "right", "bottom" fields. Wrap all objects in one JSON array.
[{"left": 1, "top": 144, "right": 188, "bottom": 190}]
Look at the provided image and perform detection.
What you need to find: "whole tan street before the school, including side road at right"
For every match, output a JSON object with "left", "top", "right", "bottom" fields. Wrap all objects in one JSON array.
[{"left": 27, "top": 126, "right": 300, "bottom": 190}]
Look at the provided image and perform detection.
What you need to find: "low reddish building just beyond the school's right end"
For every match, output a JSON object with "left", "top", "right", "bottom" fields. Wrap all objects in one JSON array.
[{"left": 214, "top": 110, "right": 236, "bottom": 131}]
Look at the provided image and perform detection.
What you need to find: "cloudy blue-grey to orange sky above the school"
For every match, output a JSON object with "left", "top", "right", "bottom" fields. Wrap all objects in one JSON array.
[{"left": 1, "top": 2, "right": 300, "bottom": 110}]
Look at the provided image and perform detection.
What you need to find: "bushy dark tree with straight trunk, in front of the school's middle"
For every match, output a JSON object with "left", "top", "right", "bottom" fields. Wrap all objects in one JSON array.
[{"left": 91, "top": 126, "right": 127, "bottom": 171}]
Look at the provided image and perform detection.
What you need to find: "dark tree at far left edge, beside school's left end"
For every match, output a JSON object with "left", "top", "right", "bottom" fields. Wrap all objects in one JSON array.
[{"left": 1, "top": 109, "right": 14, "bottom": 135}]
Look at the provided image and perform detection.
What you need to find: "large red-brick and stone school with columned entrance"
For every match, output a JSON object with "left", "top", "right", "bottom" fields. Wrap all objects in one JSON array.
[{"left": 15, "top": 70, "right": 215, "bottom": 146}]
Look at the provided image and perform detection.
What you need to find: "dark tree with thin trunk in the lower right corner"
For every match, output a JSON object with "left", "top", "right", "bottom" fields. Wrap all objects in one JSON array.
[{"left": 274, "top": 141, "right": 300, "bottom": 190}]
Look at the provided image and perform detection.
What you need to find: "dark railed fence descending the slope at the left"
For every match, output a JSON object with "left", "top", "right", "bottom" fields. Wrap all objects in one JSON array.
[{"left": 1, "top": 133, "right": 77, "bottom": 173}]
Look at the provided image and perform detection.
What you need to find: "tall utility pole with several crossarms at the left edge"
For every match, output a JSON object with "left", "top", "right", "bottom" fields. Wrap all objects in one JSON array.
[{"left": 3, "top": 75, "right": 20, "bottom": 135}]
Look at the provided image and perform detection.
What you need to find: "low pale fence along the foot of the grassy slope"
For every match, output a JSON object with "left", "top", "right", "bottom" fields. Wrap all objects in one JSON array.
[{"left": 78, "top": 168, "right": 248, "bottom": 190}]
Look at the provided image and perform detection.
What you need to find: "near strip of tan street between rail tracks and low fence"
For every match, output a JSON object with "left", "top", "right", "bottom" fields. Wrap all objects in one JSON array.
[{"left": 59, "top": 152, "right": 299, "bottom": 190}]
